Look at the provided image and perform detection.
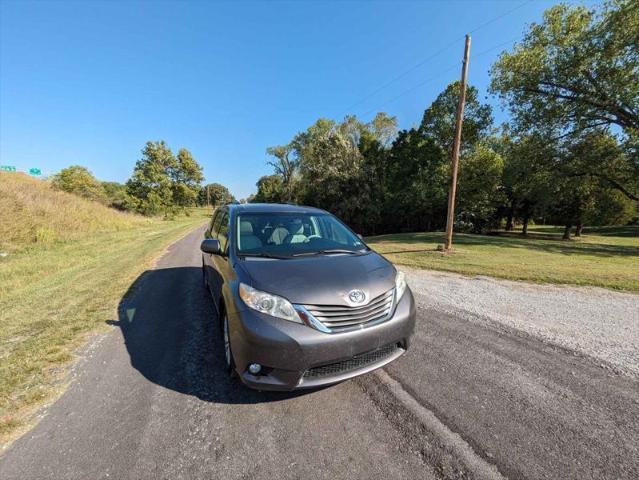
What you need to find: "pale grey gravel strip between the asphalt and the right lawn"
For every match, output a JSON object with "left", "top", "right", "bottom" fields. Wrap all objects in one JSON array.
[{"left": 399, "top": 266, "right": 639, "bottom": 377}]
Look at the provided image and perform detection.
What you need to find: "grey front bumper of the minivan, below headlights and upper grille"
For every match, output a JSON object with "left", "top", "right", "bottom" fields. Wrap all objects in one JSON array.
[{"left": 229, "top": 288, "right": 415, "bottom": 390}]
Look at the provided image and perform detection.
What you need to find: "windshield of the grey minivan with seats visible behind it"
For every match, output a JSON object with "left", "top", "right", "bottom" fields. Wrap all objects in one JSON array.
[{"left": 236, "top": 213, "right": 368, "bottom": 258}]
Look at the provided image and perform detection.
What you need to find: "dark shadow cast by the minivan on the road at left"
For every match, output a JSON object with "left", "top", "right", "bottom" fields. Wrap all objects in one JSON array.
[{"left": 106, "top": 267, "right": 312, "bottom": 404}]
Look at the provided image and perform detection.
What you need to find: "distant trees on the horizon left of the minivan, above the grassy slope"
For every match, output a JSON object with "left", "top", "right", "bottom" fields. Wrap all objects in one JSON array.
[{"left": 51, "top": 141, "right": 235, "bottom": 217}]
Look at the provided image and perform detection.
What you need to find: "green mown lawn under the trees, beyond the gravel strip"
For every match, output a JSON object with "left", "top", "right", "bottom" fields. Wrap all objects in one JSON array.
[{"left": 367, "top": 226, "right": 639, "bottom": 292}]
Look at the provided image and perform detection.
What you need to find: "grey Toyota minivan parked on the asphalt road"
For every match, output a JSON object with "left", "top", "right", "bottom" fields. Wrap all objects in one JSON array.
[{"left": 201, "top": 204, "right": 415, "bottom": 390}]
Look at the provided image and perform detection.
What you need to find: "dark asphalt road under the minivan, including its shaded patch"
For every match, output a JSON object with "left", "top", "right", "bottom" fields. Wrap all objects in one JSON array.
[{"left": 0, "top": 230, "right": 639, "bottom": 480}]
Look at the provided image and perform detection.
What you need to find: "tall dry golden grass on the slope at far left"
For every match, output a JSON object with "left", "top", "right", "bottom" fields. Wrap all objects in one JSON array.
[{"left": 0, "top": 172, "right": 150, "bottom": 251}]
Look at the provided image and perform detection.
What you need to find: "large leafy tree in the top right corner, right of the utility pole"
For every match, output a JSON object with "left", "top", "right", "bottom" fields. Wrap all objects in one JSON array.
[{"left": 491, "top": 0, "right": 639, "bottom": 200}]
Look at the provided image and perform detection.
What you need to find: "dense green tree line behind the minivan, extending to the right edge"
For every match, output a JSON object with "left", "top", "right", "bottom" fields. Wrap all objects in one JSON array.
[{"left": 251, "top": 0, "right": 639, "bottom": 238}]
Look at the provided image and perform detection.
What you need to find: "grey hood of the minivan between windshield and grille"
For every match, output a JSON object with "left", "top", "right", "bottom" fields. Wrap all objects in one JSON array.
[{"left": 240, "top": 252, "right": 395, "bottom": 306}]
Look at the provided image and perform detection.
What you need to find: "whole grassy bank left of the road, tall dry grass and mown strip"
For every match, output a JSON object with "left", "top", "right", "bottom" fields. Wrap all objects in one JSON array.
[{"left": 0, "top": 172, "right": 205, "bottom": 448}]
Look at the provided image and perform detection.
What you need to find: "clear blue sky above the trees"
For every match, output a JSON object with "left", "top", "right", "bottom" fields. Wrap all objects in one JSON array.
[{"left": 0, "top": 0, "right": 592, "bottom": 198}]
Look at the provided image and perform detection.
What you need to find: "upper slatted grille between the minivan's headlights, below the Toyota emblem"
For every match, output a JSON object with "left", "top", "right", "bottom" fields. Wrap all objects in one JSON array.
[{"left": 304, "top": 289, "right": 395, "bottom": 331}]
